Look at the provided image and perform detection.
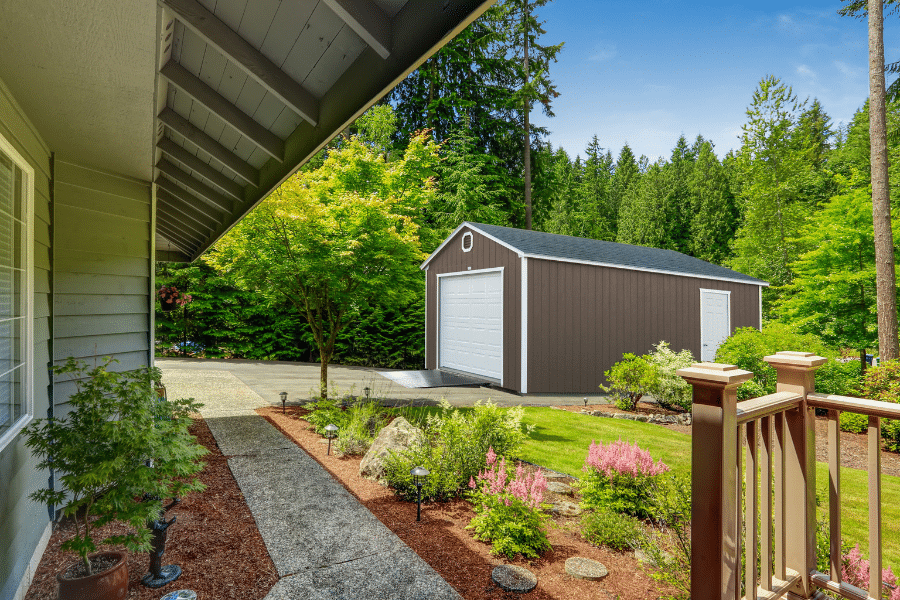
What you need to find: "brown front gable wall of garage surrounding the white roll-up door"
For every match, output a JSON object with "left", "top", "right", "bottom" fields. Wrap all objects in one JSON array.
[{"left": 425, "top": 227, "right": 522, "bottom": 391}]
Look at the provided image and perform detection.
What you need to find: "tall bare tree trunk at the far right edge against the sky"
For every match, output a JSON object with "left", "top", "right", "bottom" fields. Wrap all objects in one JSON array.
[{"left": 869, "top": 0, "right": 900, "bottom": 360}]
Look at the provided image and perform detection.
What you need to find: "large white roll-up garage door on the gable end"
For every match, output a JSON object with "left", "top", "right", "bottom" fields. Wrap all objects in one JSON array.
[{"left": 438, "top": 271, "right": 503, "bottom": 381}]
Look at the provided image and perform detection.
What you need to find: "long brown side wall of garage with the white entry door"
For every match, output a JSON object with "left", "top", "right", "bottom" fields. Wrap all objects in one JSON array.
[{"left": 528, "top": 259, "right": 759, "bottom": 393}]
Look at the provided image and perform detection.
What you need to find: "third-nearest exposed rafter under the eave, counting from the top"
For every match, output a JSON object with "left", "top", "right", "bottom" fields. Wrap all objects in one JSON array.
[{"left": 159, "top": 59, "right": 284, "bottom": 162}]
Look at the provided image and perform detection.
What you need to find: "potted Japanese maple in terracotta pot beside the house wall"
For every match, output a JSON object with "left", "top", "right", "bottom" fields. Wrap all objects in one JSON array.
[{"left": 25, "top": 358, "right": 207, "bottom": 600}]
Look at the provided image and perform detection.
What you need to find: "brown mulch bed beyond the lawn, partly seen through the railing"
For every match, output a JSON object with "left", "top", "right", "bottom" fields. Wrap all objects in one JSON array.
[{"left": 558, "top": 402, "right": 900, "bottom": 477}]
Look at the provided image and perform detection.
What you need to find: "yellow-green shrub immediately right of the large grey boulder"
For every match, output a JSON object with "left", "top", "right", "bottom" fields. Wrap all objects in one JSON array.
[{"left": 385, "top": 401, "right": 530, "bottom": 500}]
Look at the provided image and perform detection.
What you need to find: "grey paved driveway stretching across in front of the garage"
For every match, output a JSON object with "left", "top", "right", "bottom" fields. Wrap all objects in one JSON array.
[{"left": 156, "top": 358, "right": 609, "bottom": 406}]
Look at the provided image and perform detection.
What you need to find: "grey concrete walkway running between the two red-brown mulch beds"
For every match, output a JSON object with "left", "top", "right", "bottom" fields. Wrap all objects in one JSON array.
[{"left": 157, "top": 360, "right": 461, "bottom": 600}]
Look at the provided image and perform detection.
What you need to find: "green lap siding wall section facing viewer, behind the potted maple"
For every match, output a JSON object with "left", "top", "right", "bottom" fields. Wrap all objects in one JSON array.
[{"left": 53, "top": 159, "right": 153, "bottom": 412}]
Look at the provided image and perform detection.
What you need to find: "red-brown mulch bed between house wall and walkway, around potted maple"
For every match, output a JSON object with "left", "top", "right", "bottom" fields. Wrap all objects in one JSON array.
[{"left": 25, "top": 419, "right": 278, "bottom": 600}]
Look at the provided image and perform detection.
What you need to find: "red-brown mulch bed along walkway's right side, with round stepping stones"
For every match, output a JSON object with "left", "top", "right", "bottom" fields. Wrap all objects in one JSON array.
[{"left": 257, "top": 407, "right": 672, "bottom": 600}]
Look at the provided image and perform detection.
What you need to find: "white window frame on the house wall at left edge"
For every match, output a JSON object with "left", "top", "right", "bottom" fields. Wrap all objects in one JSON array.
[{"left": 0, "top": 135, "right": 35, "bottom": 452}]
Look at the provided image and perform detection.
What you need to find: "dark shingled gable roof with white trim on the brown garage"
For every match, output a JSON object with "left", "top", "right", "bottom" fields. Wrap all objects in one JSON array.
[{"left": 420, "top": 221, "right": 769, "bottom": 287}]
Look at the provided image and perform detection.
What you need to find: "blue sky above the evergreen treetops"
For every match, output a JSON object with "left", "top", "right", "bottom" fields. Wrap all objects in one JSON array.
[{"left": 534, "top": 0, "right": 900, "bottom": 160}]
